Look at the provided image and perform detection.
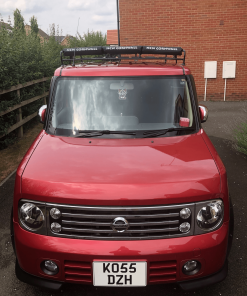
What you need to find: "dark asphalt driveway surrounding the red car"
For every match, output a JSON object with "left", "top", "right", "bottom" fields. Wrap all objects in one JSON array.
[{"left": 0, "top": 101, "right": 247, "bottom": 296}]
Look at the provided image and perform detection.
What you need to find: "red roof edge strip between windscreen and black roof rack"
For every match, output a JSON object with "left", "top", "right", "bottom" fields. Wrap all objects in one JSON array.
[{"left": 55, "top": 64, "right": 191, "bottom": 76}]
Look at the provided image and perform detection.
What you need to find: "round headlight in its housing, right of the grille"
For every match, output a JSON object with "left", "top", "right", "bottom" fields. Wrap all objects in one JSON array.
[{"left": 196, "top": 200, "right": 224, "bottom": 234}]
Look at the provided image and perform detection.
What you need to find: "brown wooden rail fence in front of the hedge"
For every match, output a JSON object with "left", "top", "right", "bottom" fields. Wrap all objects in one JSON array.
[{"left": 0, "top": 77, "right": 51, "bottom": 139}]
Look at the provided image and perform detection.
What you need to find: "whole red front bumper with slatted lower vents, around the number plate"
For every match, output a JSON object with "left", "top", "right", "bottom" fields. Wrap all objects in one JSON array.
[{"left": 14, "top": 222, "right": 229, "bottom": 290}]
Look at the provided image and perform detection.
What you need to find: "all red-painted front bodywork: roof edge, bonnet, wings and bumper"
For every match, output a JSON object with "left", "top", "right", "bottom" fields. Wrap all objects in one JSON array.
[{"left": 14, "top": 64, "right": 229, "bottom": 283}]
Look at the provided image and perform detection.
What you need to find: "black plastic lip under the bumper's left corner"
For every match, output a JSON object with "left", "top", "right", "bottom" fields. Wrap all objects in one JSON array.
[{"left": 15, "top": 259, "right": 63, "bottom": 291}]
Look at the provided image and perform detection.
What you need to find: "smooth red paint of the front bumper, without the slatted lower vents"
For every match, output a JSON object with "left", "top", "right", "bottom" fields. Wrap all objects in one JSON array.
[{"left": 14, "top": 222, "right": 228, "bottom": 283}]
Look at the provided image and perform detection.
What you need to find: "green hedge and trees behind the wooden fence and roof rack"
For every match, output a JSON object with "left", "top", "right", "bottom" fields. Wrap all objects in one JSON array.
[{"left": 0, "top": 9, "right": 106, "bottom": 149}]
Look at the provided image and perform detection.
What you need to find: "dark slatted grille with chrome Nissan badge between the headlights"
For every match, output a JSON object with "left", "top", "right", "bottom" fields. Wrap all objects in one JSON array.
[{"left": 46, "top": 204, "right": 194, "bottom": 240}]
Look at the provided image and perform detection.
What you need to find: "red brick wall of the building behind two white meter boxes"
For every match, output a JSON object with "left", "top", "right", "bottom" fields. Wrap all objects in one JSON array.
[{"left": 119, "top": 0, "right": 247, "bottom": 100}]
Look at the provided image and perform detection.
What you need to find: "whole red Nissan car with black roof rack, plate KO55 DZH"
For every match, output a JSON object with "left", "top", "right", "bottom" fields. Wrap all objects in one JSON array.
[{"left": 11, "top": 46, "right": 233, "bottom": 290}]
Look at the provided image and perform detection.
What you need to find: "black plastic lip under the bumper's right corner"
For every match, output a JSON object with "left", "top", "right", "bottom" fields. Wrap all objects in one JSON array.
[{"left": 178, "top": 260, "right": 228, "bottom": 291}]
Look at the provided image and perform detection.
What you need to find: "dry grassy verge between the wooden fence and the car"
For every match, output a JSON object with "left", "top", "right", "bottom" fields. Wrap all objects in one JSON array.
[{"left": 0, "top": 123, "right": 43, "bottom": 183}]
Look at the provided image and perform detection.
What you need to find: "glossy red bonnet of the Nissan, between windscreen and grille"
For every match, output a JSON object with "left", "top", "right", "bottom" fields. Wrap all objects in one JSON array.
[{"left": 22, "top": 130, "right": 220, "bottom": 205}]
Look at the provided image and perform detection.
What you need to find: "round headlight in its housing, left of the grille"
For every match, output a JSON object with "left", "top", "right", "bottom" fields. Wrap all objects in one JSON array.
[{"left": 19, "top": 202, "right": 45, "bottom": 234}]
